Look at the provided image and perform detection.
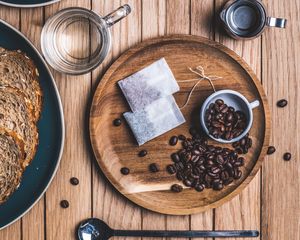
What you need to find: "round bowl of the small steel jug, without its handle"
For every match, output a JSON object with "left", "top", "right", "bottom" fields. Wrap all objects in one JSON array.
[{"left": 224, "top": 0, "right": 266, "bottom": 38}]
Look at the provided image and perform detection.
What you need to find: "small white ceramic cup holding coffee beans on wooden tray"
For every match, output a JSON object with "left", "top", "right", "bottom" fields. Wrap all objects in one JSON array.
[{"left": 200, "top": 89, "right": 259, "bottom": 143}]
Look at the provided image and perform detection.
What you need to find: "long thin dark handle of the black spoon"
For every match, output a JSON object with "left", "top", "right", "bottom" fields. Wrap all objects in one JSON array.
[{"left": 113, "top": 230, "right": 259, "bottom": 238}]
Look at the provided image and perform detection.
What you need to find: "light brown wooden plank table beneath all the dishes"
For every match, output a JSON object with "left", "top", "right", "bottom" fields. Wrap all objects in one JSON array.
[{"left": 0, "top": 0, "right": 300, "bottom": 240}]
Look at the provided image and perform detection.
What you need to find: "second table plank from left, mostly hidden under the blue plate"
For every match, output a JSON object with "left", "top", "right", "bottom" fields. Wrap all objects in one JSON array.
[{"left": 20, "top": 8, "right": 46, "bottom": 240}]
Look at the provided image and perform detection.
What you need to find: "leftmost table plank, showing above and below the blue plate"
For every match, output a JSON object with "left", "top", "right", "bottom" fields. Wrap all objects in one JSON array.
[{"left": 0, "top": 6, "right": 22, "bottom": 240}]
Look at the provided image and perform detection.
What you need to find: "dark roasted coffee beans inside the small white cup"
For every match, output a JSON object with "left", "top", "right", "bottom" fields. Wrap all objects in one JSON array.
[{"left": 205, "top": 99, "right": 247, "bottom": 140}]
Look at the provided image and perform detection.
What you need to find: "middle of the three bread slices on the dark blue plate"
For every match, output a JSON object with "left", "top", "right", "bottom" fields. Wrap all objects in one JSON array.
[{"left": 0, "top": 87, "right": 38, "bottom": 168}]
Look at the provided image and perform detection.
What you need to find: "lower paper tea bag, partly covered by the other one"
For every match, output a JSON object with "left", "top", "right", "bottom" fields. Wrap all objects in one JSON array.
[{"left": 124, "top": 95, "right": 185, "bottom": 146}]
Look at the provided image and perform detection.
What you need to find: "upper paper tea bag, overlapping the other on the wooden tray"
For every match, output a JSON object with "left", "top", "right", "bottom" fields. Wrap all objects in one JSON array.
[{"left": 118, "top": 58, "right": 179, "bottom": 112}]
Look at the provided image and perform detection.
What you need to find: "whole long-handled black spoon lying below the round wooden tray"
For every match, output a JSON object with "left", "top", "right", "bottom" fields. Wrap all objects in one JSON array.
[{"left": 77, "top": 218, "right": 259, "bottom": 240}]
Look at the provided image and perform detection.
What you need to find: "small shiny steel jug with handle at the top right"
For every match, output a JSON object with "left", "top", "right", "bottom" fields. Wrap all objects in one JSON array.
[{"left": 220, "top": 0, "right": 287, "bottom": 39}]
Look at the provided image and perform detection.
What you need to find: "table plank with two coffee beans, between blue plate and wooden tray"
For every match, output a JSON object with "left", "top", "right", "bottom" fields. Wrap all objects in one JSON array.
[{"left": 45, "top": 0, "right": 92, "bottom": 240}]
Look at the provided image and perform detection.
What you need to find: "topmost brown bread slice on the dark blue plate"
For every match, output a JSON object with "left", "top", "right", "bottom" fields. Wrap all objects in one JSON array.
[{"left": 0, "top": 48, "right": 42, "bottom": 121}]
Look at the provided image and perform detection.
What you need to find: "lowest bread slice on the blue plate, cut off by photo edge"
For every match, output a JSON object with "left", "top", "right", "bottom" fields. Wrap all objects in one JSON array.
[{"left": 0, "top": 128, "right": 24, "bottom": 204}]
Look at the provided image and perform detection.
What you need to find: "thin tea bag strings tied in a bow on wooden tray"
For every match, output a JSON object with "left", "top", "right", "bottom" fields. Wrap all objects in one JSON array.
[{"left": 177, "top": 66, "right": 222, "bottom": 109}]
